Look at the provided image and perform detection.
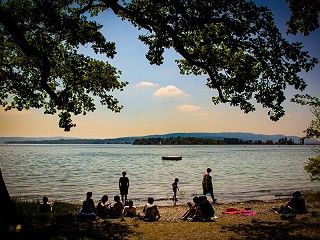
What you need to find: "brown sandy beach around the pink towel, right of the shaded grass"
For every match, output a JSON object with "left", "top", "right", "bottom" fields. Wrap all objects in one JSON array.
[{"left": 106, "top": 193, "right": 320, "bottom": 240}]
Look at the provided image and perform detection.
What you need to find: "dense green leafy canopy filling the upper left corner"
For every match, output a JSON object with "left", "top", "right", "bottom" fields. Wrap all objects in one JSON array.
[{"left": 0, "top": 0, "right": 127, "bottom": 131}]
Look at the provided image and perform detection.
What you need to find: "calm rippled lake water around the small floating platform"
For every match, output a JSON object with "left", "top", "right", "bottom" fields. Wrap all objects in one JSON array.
[{"left": 0, "top": 145, "right": 319, "bottom": 206}]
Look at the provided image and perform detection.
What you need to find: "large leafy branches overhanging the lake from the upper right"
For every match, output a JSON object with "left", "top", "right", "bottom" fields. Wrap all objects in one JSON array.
[{"left": 129, "top": 0, "right": 317, "bottom": 121}]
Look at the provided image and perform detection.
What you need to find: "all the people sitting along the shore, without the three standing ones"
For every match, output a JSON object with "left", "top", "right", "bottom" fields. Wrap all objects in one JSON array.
[{"left": 39, "top": 191, "right": 308, "bottom": 221}]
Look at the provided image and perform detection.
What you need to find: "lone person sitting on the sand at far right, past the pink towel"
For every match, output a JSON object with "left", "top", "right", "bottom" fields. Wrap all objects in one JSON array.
[{"left": 276, "top": 191, "right": 308, "bottom": 214}]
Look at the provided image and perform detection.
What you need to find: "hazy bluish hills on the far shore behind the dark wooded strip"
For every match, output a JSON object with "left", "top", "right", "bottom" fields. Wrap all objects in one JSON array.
[{"left": 0, "top": 132, "right": 317, "bottom": 144}]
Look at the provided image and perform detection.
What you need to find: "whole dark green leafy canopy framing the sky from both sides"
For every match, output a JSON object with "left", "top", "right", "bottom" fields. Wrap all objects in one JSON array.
[{"left": 0, "top": 0, "right": 317, "bottom": 131}]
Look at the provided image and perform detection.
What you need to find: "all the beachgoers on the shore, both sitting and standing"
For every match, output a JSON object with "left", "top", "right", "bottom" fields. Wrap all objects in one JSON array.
[{"left": 40, "top": 168, "right": 307, "bottom": 221}]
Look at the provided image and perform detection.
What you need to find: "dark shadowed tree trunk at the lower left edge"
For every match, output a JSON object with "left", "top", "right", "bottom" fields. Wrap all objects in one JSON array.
[{"left": 0, "top": 169, "right": 18, "bottom": 231}]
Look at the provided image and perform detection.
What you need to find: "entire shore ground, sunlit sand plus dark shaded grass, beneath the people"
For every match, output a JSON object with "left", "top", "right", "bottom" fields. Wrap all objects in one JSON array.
[{"left": 0, "top": 191, "right": 320, "bottom": 240}]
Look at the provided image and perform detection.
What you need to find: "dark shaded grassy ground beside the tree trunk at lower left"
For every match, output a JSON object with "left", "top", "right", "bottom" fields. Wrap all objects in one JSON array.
[{"left": 4, "top": 199, "right": 130, "bottom": 240}]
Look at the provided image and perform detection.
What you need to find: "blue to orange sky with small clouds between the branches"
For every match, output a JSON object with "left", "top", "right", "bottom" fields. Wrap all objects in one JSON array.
[{"left": 0, "top": 0, "right": 320, "bottom": 138}]
